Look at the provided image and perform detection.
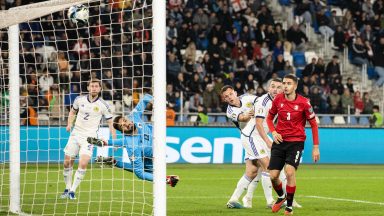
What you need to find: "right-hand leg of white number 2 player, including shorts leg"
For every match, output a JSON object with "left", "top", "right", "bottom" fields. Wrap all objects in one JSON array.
[{"left": 69, "top": 138, "right": 93, "bottom": 199}]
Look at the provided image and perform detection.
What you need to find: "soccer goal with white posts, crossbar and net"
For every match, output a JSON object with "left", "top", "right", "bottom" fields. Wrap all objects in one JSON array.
[{"left": 0, "top": 0, "right": 166, "bottom": 215}]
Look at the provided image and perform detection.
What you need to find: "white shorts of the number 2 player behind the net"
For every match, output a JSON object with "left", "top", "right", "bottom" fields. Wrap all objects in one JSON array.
[{"left": 64, "top": 134, "right": 93, "bottom": 158}]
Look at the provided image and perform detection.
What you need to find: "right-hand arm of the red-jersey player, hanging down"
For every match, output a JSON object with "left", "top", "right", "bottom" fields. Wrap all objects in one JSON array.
[{"left": 304, "top": 101, "right": 320, "bottom": 162}]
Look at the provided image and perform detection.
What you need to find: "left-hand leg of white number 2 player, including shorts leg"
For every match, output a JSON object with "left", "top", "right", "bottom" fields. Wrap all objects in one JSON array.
[{"left": 61, "top": 136, "right": 79, "bottom": 198}]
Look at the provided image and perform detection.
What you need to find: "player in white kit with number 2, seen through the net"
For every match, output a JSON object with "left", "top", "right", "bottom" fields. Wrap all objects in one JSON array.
[{"left": 61, "top": 79, "right": 116, "bottom": 199}]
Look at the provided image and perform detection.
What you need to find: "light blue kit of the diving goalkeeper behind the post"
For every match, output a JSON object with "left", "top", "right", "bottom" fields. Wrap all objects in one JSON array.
[{"left": 108, "top": 94, "right": 153, "bottom": 181}]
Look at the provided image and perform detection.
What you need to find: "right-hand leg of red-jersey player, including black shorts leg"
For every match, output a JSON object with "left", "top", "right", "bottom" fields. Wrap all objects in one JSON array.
[{"left": 285, "top": 142, "right": 304, "bottom": 214}]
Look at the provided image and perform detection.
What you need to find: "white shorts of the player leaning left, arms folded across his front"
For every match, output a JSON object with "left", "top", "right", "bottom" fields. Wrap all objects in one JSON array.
[{"left": 241, "top": 135, "right": 271, "bottom": 160}]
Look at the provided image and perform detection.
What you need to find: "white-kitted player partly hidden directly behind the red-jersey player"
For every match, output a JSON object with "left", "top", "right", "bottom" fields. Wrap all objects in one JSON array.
[{"left": 243, "top": 79, "right": 301, "bottom": 208}]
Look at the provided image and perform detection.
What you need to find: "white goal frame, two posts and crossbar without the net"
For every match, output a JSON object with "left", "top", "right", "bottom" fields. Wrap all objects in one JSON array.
[{"left": 0, "top": 0, "right": 166, "bottom": 216}]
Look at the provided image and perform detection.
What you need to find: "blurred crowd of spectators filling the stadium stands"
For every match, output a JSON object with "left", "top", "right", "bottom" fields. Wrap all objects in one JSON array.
[{"left": 0, "top": 0, "right": 384, "bottom": 126}]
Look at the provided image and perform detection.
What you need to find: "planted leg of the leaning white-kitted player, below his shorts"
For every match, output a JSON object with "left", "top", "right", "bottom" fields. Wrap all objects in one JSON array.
[{"left": 227, "top": 160, "right": 257, "bottom": 208}]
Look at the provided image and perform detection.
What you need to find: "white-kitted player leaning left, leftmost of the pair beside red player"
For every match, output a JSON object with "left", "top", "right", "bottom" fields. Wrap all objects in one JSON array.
[{"left": 221, "top": 85, "right": 260, "bottom": 208}]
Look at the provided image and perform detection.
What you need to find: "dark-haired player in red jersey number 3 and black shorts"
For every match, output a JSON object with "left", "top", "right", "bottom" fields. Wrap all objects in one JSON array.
[{"left": 267, "top": 74, "right": 320, "bottom": 215}]
